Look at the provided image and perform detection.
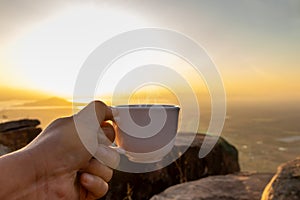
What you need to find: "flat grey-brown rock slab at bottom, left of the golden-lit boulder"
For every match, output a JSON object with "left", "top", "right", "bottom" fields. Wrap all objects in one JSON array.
[{"left": 150, "top": 172, "right": 272, "bottom": 200}]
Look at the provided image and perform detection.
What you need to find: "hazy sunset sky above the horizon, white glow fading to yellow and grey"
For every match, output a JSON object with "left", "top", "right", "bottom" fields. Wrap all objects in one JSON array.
[{"left": 0, "top": 0, "right": 300, "bottom": 100}]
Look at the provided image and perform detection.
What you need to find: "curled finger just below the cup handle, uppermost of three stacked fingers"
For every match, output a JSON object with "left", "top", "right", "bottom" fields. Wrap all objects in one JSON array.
[{"left": 94, "top": 144, "right": 120, "bottom": 169}]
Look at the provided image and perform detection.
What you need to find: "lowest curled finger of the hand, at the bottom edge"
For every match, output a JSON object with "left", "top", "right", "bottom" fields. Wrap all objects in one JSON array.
[{"left": 80, "top": 173, "right": 108, "bottom": 199}]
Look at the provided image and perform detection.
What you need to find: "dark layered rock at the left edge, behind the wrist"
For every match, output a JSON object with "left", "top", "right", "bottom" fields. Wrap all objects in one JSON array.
[{"left": 0, "top": 119, "right": 42, "bottom": 155}]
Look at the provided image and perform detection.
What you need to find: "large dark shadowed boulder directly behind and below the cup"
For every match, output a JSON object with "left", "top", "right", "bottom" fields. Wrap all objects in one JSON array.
[{"left": 101, "top": 133, "right": 240, "bottom": 200}]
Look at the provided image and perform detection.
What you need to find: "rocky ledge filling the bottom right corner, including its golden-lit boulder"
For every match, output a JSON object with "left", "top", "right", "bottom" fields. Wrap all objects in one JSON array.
[{"left": 150, "top": 158, "right": 300, "bottom": 200}]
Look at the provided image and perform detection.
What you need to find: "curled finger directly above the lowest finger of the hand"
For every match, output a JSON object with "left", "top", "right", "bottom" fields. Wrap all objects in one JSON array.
[{"left": 83, "top": 159, "right": 113, "bottom": 182}]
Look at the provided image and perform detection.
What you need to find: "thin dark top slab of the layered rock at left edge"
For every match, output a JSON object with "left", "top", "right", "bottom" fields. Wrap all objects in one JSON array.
[{"left": 0, "top": 119, "right": 40, "bottom": 132}]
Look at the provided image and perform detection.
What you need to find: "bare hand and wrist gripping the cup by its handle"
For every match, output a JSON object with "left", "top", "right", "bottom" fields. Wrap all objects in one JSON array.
[{"left": 0, "top": 101, "right": 119, "bottom": 200}]
